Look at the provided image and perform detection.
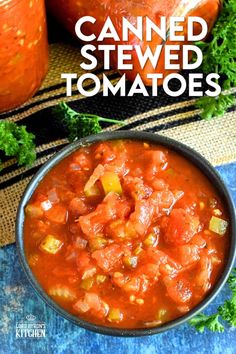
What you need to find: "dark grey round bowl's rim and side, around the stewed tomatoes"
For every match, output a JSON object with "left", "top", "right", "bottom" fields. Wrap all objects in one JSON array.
[{"left": 16, "top": 131, "right": 236, "bottom": 337}]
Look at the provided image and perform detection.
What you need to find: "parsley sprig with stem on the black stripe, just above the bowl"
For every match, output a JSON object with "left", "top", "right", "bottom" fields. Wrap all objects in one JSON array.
[{"left": 52, "top": 102, "right": 123, "bottom": 141}]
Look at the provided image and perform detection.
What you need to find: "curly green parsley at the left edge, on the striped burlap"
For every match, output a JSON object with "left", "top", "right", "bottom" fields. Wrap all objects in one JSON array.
[{"left": 0, "top": 120, "right": 36, "bottom": 170}]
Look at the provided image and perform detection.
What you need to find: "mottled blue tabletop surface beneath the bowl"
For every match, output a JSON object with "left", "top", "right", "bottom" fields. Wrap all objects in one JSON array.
[{"left": 0, "top": 163, "right": 236, "bottom": 354}]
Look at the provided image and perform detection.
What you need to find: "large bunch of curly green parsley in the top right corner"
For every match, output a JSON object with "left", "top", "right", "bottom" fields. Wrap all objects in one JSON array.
[{"left": 195, "top": 0, "right": 236, "bottom": 119}]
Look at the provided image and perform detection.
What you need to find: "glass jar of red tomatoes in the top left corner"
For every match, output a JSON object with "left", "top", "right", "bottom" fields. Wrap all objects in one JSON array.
[{"left": 0, "top": 0, "right": 48, "bottom": 112}]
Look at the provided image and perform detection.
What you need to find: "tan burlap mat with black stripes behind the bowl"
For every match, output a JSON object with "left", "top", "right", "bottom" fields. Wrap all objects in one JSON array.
[{"left": 0, "top": 44, "right": 236, "bottom": 246}]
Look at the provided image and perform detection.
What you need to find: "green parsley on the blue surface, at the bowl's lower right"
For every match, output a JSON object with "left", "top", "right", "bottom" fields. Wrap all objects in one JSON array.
[{"left": 189, "top": 268, "right": 236, "bottom": 333}]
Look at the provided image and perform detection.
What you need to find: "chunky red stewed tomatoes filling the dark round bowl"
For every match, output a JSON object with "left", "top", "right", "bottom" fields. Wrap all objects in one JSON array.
[{"left": 24, "top": 140, "right": 229, "bottom": 328}]
